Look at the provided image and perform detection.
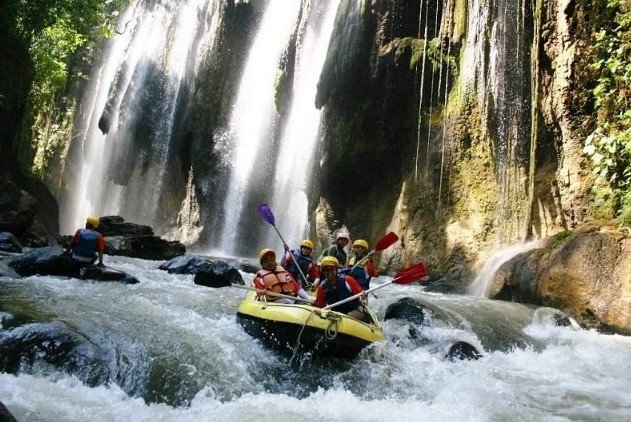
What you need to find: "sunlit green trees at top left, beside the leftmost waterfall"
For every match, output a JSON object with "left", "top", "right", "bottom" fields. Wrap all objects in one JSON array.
[{"left": 0, "top": 0, "right": 129, "bottom": 176}]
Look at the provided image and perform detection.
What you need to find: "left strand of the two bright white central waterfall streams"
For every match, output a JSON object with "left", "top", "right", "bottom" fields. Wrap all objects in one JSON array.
[{"left": 220, "top": 0, "right": 300, "bottom": 254}]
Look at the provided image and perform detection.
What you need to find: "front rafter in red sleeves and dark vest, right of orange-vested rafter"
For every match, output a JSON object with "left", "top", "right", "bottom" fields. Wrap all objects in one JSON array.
[{"left": 315, "top": 256, "right": 368, "bottom": 321}]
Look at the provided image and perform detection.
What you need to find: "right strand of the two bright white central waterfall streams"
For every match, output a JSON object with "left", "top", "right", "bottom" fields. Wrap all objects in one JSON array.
[{"left": 272, "top": 0, "right": 339, "bottom": 247}]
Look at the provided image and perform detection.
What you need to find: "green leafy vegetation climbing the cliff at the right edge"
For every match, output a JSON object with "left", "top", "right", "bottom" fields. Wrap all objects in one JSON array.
[{"left": 583, "top": 0, "right": 631, "bottom": 225}]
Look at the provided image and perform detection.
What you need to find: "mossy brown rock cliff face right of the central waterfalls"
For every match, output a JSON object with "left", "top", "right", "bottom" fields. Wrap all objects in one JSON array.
[{"left": 311, "top": 0, "right": 597, "bottom": 279}]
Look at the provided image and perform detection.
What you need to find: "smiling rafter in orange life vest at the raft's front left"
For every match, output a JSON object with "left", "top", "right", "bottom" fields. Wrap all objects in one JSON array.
[{"left": 253, "top": 248, "right": 313, "bottom": 304}]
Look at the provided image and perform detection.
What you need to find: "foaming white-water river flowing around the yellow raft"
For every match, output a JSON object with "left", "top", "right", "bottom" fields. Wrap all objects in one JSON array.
[{"left": 0, "top": 257, "right": 631, "bottom": 421}]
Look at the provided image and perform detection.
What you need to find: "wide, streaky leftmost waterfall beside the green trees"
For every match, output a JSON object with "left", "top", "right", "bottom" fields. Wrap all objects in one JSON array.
[{"left": 62, "top": 0, "right": 225, "bottom": 232}]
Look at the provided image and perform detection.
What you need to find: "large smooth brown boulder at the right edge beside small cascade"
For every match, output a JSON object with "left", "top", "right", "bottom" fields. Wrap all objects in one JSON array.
[{"left": 489, "top": 228, "right": 631, "bottom": 334}]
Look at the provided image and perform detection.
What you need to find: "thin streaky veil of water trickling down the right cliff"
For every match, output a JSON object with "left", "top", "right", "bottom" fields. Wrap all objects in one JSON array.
[{"left": 461, "top": 0, "right": 532, "bottom": 241}]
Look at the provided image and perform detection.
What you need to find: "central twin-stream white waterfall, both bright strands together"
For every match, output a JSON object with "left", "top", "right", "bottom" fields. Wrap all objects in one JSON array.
[{"left": 219, "top": 1, "right": 339, "bottom": 255}]
